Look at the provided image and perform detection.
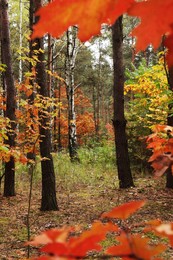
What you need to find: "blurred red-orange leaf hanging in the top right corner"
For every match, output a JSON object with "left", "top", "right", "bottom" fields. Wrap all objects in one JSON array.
[{"left": 128, "top": 0, "right": 173, "bottom": 51}]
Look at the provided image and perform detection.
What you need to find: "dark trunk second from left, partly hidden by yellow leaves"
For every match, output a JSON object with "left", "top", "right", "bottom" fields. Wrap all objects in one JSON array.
[{"left": 35, "top": 0, "right": 58, "bottom": 211}]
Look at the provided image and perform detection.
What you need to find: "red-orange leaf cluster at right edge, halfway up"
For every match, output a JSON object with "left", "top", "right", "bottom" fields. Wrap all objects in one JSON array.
[{"left": 147, "top": 125, "right": 173, "bottom": 177}]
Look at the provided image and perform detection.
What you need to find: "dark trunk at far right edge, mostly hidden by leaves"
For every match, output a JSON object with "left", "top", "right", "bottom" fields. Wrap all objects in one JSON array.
[{"left": 166, "top": 67, "right": 173, "bottom": 189}]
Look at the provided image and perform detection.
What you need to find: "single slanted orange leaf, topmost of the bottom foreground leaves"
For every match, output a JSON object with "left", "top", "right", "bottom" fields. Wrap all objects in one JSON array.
[{"left": 101, "top": 200, "right": 145, "bottom": 219}]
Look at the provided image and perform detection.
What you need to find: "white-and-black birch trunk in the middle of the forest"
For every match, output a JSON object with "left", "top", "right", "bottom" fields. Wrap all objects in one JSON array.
[{"left": 65, "top": 26, "right": 79, "bottom": 161}]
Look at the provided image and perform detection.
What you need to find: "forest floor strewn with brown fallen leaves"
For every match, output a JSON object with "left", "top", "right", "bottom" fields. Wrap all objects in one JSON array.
[{"left": 0, "top": 168, "right": 173, "bottom": 260}]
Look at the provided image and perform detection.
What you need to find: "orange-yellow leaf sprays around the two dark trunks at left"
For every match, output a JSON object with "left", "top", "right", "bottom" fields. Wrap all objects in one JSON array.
[{"left": 0, "top": 78, "right": 39, "bottom": 164}]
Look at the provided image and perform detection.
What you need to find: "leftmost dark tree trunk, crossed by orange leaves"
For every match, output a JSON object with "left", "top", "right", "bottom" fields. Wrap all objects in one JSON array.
[{"left": 0, "top": 0, "right": 16, "bottom": 197}]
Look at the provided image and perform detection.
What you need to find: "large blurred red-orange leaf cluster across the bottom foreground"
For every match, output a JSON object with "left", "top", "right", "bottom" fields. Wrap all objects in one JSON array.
[{"left": 27, "top": 201, "right": 173, "bottom": 260}]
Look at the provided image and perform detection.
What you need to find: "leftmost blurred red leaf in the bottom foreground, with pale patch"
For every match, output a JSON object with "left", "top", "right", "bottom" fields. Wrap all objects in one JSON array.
[{"left": 29, "top": 221, "right": 118, "bottom": 259}]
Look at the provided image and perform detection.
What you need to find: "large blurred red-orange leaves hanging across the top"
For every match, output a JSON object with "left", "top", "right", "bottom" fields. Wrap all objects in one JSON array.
[{"left": 32, "top": 0, "right": 173, "bottom": 65}]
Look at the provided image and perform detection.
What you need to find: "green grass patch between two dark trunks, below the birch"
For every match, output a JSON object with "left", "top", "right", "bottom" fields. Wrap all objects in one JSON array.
[{"left": 54, "top": 147, "right": 117, "bottom": 191}]
